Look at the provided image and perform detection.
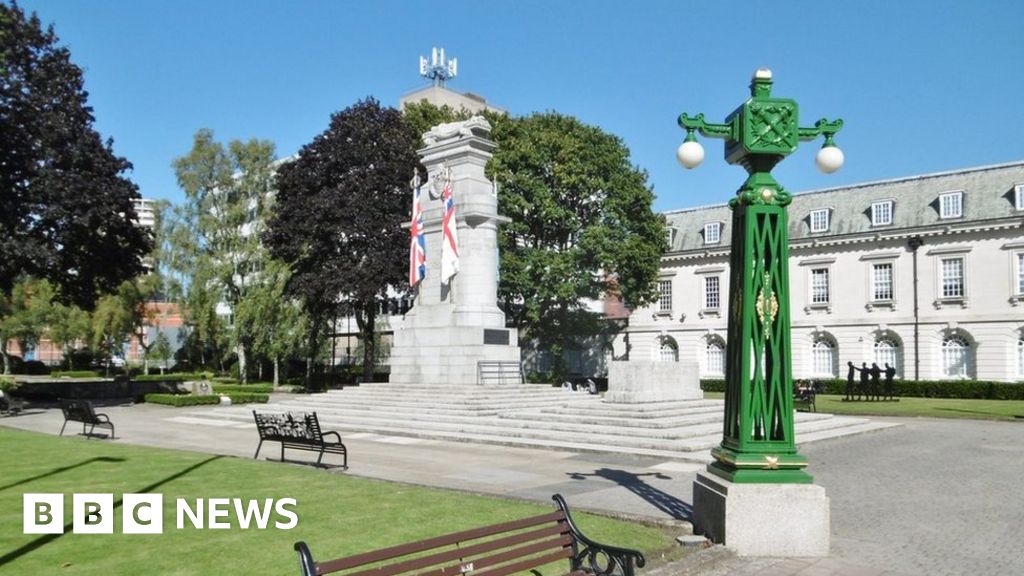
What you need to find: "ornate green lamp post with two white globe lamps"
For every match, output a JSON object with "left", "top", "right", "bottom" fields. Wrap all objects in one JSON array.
[{"left": 677, "top": 70, "right": 843, "bottom": 484}]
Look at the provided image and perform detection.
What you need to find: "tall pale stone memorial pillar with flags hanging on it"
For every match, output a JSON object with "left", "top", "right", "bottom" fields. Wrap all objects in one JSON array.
[{"left": 390, "top": 116, "right": 521, "bottom": 384}]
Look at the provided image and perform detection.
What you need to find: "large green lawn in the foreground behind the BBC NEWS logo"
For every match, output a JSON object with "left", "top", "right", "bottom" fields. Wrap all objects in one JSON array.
[{"left": 0, "top": 428, "right": 682, "bottom": 576}]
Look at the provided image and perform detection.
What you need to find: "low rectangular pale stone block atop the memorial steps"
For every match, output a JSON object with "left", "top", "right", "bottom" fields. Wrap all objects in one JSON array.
[{"left": 604, "top": 360, "right": 703, "bottom": 404}]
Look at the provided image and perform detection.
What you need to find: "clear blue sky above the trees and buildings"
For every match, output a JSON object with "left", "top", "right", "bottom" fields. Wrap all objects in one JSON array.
[{"left": 22, "top": 0, "right": 1024, "bottom": 210}]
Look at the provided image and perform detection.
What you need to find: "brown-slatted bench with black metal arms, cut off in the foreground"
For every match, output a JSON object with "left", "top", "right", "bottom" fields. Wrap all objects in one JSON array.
[{"left": 295, "top": 494, "right": 645, "bottom": 576}]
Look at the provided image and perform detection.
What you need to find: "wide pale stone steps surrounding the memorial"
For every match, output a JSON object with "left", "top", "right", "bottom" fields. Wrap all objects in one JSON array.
[{"left": 180, "top": 383, "right": 891, "bottom": 462}]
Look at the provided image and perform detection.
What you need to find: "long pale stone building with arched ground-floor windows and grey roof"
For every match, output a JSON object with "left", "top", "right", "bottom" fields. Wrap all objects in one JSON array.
[{"left": 615, "top": 161, "right": 1024, "bottom": 381}]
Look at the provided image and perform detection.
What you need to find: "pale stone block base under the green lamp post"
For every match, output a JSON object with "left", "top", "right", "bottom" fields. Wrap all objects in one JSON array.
[{"left": 693, "top": 472, "right": 830, "bottom": 557}]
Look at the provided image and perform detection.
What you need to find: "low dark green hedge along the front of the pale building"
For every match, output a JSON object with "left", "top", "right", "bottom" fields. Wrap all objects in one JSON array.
[{"left": 700, "top": 378, "right": 1024, "bottom": 400}]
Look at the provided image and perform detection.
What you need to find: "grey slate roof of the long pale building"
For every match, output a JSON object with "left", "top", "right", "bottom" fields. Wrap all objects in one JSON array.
[{"left": 664, "top": 161, "right": 1024, "bottom": 253}]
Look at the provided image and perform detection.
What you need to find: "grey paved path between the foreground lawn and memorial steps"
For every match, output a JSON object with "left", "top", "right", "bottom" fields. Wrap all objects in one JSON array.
[{"left": 0, "top": 405, "right": 1024, "bottom": 576}]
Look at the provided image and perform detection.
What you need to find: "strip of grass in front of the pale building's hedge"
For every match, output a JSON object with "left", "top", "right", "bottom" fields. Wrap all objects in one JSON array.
[{"left": 705, "top": 393, "right": 1024, "bottom": 420}]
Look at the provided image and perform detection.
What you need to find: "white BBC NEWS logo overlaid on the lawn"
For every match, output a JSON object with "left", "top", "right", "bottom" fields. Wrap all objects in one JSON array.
[{"left": 22, "top": 494, "right": 299, "bottom": 534}]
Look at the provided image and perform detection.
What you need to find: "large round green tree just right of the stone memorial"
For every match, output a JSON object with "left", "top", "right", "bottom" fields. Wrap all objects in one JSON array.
[{"left": 487, "top": 112, "right": 668, "bottom": 376}]
